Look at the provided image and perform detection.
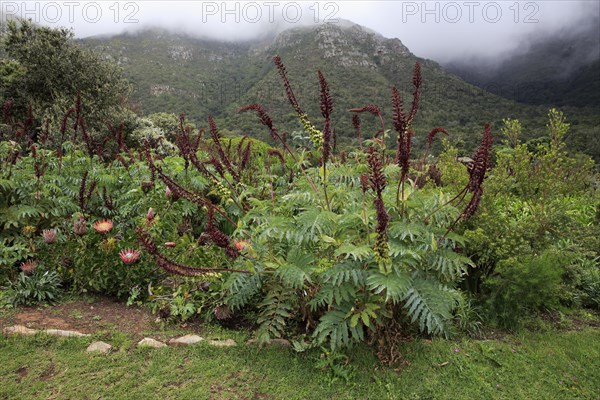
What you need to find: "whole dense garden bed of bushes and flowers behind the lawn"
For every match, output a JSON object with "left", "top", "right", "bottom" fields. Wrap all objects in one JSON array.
[{"left": 0, "top": 20, "right": 600, "bottom": 372}]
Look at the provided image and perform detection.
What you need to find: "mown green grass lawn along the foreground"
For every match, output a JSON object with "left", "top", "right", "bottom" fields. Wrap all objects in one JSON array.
[{"left": 0, "top": 328, "right": 600, "bottom": 400}]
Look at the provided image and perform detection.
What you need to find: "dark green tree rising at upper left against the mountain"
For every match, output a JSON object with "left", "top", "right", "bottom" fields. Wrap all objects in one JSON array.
[{"left": 0, "top": 20, "right": 131, "bottom": 134}]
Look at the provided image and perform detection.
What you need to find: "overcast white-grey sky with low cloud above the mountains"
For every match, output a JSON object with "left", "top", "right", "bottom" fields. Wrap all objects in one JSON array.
[{"left": 1, "top": 0, "right": 600, "bottom": 62}]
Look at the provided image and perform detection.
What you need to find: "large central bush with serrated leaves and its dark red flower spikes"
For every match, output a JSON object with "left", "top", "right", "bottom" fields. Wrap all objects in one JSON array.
[{"left": 180, "top": 58, "right": 491, "bottom": 350}]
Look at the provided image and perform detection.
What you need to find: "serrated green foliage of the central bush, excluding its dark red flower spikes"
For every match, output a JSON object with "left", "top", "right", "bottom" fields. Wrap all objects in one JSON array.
[{"left": 225, "top": 167, "right": 470, "bottom": 348}]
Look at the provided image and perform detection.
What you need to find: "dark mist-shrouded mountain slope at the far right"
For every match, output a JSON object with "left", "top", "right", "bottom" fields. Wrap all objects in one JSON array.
[{"left": 444, "top": 17, "right": 600, "bottom": 107}]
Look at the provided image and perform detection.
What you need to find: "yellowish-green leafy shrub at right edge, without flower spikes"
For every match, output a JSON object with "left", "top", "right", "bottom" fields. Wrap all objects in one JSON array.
[{"left": 463, "top": 110, "right": 600, "bottom": 301}]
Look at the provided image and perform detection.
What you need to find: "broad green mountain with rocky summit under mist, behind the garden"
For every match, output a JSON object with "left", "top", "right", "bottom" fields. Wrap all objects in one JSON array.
[{"left": 83, "top": 24, "right": 600, "bottom": 154}]
